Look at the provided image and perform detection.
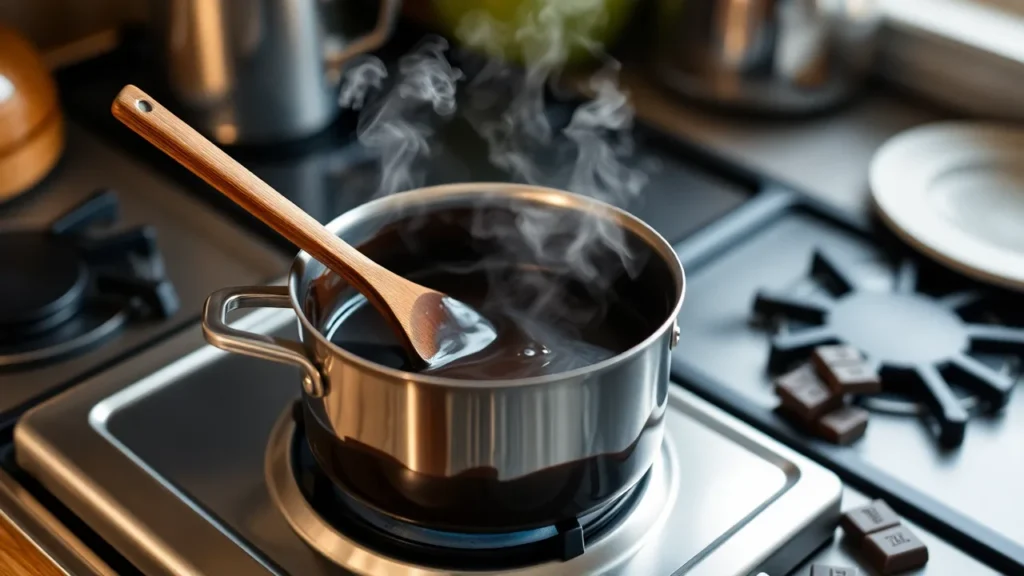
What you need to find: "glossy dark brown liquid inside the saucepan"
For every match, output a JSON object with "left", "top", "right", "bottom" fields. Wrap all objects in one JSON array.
[{"left": 331, "top": 260, "right": 653, "bottom": 380}]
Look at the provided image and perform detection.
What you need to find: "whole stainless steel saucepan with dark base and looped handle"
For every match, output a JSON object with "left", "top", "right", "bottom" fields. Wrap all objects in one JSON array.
[{"left": 203, "top": 183, "right": 685, "bottom": 532}]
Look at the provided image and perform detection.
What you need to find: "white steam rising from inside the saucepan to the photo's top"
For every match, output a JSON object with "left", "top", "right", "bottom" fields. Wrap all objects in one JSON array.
[{"left": 340, "top": 0, "right": 647, "bottom": 369}]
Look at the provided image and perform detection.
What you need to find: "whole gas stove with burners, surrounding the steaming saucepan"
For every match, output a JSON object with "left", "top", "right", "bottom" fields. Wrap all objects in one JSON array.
[{"left": 0, "top": 22, "right": 1024, "bottom": 576}]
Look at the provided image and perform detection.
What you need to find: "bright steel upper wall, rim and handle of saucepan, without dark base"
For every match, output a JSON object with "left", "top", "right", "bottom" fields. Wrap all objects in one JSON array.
[{"left": 204, "top": 183, "right": 685, "bottom": 479}]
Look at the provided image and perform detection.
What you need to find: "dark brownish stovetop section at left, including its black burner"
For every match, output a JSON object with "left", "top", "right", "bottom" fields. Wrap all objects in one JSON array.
[{"left": 0, "top": 121, "right": 288, "bottom": 429}]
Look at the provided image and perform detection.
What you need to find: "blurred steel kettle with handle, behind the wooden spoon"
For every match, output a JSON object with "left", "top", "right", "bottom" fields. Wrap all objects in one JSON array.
[{"left": 151, "top": 0, "right": 400, "bottom": 145}]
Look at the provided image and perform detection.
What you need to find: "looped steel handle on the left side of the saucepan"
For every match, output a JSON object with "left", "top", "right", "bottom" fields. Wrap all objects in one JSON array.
[{"left": 203, "top": 286, "right": 324, "bottom": 398}]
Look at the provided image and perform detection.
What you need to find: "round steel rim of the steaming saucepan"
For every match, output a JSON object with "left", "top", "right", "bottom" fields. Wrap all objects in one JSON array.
[{"left": 288, "top": 182, "right": 686, "bottom": 389}]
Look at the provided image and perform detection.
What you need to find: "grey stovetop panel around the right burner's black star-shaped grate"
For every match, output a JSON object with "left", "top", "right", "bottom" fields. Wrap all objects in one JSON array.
[{"left": 673, "top": 195, "right": 1024, "bottom": 570}]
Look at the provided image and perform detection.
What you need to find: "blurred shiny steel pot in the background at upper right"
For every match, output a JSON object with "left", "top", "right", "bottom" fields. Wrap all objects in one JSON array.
[{"left": 652, "top": 0, "right": 881, "bottom": 114}]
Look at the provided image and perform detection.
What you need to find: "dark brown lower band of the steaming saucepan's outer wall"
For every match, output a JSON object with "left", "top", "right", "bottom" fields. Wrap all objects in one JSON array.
[{"left": 303, "top": 399, "right": 663, "bottom": 532}]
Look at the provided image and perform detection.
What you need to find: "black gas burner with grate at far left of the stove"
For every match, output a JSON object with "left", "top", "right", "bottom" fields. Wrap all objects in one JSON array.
[{"left": 0, "top": 190, "right": 178, "bottom": 368}]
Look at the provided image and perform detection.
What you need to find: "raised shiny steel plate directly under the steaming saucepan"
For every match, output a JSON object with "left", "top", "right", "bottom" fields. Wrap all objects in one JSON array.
[{"left": 15, "top": 311, "right": 842, "bottom": 576}]
